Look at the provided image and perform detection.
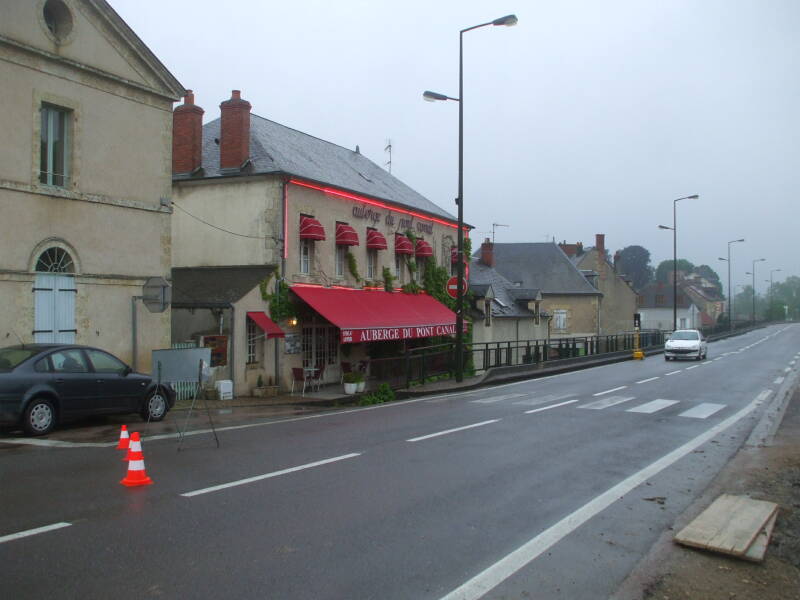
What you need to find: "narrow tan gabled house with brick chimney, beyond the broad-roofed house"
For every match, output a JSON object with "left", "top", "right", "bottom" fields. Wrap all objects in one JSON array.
[{"left": 559, "top": 233, "right": 637, "bottom": 335}]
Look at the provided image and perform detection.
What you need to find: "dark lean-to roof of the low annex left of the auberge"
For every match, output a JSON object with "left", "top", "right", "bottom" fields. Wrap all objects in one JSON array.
[{"left": 172, "top": 266, "right": 275, "bottom": 308}]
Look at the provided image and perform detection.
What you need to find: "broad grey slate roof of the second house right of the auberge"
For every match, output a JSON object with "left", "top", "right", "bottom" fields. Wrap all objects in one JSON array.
[{"left": 494, "top": 242, "right": 601, "bottom": 295}]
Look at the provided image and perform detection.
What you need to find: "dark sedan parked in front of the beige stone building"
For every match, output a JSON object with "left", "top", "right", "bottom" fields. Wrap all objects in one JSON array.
[{"left": 0, "top": 344, "right": 175, "bottom": 435}]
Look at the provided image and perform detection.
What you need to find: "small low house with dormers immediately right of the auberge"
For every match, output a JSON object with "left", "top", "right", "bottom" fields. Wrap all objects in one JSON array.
[{"left": 469, "top": 239, "right": 548, "bottom": 350}]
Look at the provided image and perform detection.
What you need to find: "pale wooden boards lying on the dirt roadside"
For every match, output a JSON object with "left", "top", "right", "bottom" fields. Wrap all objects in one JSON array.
[{"left": 675, "top": 494, "right": 778, "bottom": 556}]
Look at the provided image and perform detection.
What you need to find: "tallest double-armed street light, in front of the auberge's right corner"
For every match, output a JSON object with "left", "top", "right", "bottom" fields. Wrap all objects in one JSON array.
[{"left": 422, "top": 15, "right": 517, "bottom": 381}]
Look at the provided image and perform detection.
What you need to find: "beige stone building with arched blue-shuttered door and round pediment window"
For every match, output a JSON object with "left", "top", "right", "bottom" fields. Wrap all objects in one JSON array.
[{"left": 0, "top": 0, "right": 184, "bottom": 370}]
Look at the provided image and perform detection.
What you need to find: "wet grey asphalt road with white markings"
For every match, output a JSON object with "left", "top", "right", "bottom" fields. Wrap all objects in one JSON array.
[{"left": 0, "top": 325, "right": 800, "bottom": 600}]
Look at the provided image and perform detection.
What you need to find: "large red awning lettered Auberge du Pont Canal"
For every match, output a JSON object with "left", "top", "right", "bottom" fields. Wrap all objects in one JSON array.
[{"left": 292, "top": 285, "right": 466, "bottom": 344}]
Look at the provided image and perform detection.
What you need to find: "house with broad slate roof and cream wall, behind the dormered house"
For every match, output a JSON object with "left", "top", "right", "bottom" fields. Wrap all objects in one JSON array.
[{"left": 493, "top": 242, "right": 603, "bottom": 338}]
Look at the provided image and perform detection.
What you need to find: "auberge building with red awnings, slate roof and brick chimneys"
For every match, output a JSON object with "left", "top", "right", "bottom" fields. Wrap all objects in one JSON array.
[{"left": 173, "top": 91, "right": 466, "bottom": 395}]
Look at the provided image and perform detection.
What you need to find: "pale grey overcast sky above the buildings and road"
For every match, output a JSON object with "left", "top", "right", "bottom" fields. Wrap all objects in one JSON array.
[{"left": 110, "top": 0, "right": 800, "bottom": 290}]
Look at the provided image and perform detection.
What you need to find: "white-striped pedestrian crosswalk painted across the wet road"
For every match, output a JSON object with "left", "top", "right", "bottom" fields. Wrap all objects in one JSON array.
[{"left": 470, "top": 393, "right": 727, "bottom": 419}]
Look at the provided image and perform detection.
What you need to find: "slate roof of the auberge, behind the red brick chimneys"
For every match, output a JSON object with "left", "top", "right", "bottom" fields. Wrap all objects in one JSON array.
[{"left": 191, "top": 114, "right": 457, "bottom": 221}]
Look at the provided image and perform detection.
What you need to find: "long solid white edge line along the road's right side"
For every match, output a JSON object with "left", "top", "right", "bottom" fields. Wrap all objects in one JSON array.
[{"left": 441, "top": 390, "right": 769, "bottom": 600}]
